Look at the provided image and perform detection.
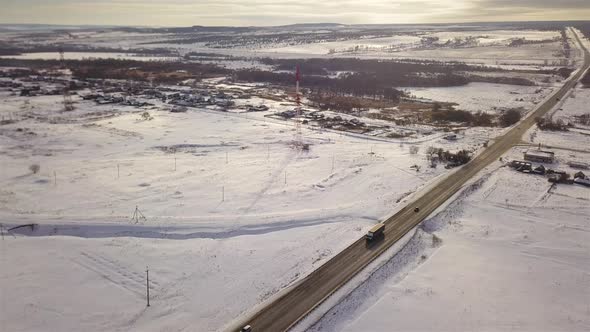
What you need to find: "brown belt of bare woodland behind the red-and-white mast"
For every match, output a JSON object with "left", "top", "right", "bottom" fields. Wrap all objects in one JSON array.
[{"left": 234, "top": 58, "right": 535, "bottom": 100}]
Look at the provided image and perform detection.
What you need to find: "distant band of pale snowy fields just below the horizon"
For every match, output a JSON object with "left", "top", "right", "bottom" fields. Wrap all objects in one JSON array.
[{"left": 0, "top": 25, "right": 576, "bottom": 69}]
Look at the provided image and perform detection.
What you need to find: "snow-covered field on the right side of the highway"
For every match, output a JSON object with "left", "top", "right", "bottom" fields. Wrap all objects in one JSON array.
[{"left": 309, "top": 149, "right": 590, "bottom": 331}]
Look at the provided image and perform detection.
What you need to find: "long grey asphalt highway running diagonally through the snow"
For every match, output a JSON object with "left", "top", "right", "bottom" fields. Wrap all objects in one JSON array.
[{"left": 229, "top": 29, "right": 590, "bottom": 332}]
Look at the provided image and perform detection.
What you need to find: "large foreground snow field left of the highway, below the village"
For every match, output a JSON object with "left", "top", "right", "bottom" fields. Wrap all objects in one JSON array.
[{"left": 0, "top": 89, "right": 462, "bottom": 331}]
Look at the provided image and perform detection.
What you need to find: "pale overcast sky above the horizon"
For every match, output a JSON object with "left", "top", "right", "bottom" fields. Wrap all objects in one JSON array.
[{"left": 0, "top": 0, "right": 590, "bottom": 26}]
